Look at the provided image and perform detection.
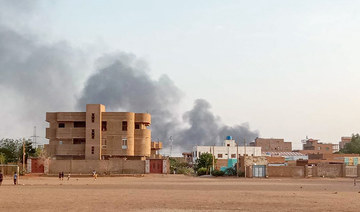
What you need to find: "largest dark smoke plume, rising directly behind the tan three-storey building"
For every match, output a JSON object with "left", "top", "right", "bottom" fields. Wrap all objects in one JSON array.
[{"left": 77, "top": 53, "right": 182, "bottom": 142}]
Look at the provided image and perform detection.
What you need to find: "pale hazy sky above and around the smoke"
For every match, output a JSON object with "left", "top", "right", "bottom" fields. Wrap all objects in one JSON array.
[{"left": 0, "top": 0, "right": 360, "bottom": 148}]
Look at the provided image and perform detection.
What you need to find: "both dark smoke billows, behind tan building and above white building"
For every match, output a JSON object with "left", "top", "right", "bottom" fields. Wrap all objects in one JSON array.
[{"left": 77, "top": 56, "right": 258, "bottom": 149}]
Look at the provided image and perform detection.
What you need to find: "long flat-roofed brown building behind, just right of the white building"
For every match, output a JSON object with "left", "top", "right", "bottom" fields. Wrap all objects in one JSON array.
[{"left": 251, "top": 138, "right": 292, "bottom": 152}]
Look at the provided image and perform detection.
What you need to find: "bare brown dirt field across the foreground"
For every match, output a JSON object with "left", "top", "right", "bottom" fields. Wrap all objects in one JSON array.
[{"left": 0, "top": 175, "right": 360, "bottom": 211}]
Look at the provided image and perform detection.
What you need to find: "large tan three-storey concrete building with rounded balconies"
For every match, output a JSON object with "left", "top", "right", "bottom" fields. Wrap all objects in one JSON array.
[{"left": 45, "top": 104, "right": 162, "bottom": 160}]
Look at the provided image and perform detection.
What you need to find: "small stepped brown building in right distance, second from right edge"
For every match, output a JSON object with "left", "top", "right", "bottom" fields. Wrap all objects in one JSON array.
[{"left": 299, "top": 139, "right": 338, "bottom": 154}]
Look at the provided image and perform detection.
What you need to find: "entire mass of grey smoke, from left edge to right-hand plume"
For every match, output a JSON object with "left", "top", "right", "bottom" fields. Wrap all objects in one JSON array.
[{"left": 0, "top": 0, "right": 258, "bottom": 150}]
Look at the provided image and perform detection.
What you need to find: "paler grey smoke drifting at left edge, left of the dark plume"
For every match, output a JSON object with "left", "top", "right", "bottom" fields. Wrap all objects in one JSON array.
[{"left": 0, "top": 0, "right": 87, "bottom": 138}]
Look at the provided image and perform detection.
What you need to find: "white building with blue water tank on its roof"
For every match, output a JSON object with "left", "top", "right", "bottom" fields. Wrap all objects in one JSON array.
[{"left": 192, "top": 136, "right": 261, "bottom": 162}]
